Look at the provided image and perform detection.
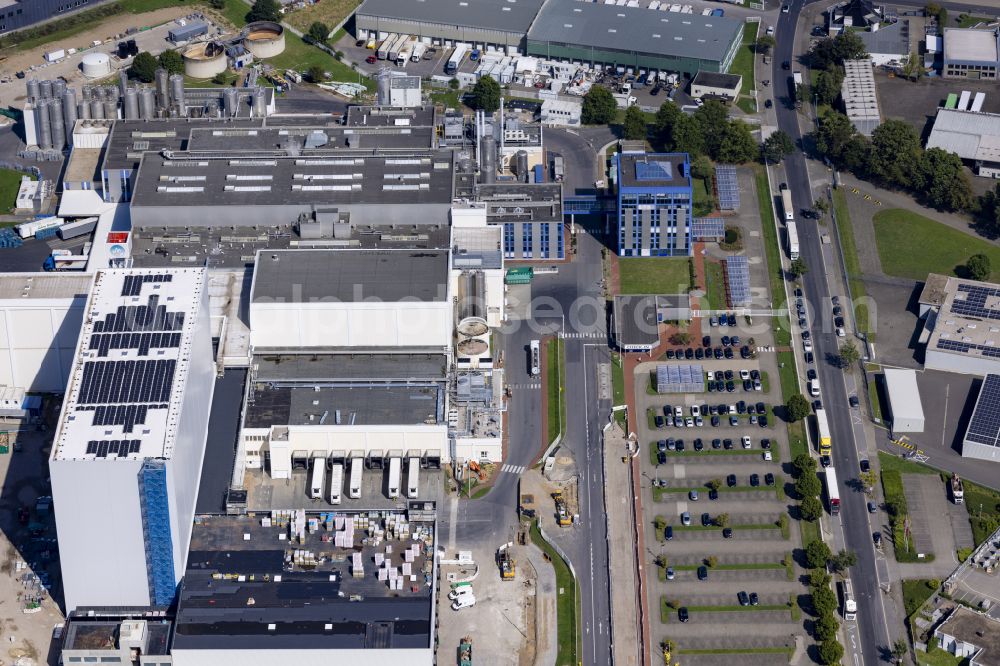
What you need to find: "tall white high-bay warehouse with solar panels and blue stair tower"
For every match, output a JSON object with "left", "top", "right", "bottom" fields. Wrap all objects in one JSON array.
[{"left": 49, "top": 268, "right": 215, "bottom": 611}]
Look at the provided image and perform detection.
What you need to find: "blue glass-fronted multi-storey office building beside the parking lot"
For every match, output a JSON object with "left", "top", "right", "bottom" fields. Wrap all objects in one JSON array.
[{"left": 615, "top": 152, "right": 693, "bottom": 257}]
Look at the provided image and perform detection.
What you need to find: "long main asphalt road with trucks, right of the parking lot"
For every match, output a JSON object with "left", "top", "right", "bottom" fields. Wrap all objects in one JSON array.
[{"left": 772, "top": 3, "right": 892, "bottom": 666}]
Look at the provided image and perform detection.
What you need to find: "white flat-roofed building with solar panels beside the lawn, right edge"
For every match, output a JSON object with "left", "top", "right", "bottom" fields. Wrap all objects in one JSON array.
[{"left": 919, "top": 273, "right": 1000, "bottom": 375}]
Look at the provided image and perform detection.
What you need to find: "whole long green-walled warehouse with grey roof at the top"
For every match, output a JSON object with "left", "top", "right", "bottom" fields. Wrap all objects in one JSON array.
[{"left": 527, "top": 0, "right": 743, "bottom": 77}]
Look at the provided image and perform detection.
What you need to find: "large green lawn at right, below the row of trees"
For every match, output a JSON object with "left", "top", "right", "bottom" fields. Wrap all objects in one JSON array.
[{"left": 873, "top": 208, "right": 1000, "bottom": 282}]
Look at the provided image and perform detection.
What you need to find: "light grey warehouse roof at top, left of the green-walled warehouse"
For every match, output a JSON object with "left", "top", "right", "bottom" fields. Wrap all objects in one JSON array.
[{"left": 355, "top": 0, "right": 543, "bottom": 35}]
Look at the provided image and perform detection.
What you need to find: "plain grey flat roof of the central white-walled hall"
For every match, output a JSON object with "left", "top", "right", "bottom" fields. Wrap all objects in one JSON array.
[{"left": 251, "top": 250, "right": 448, "bottom": 303}]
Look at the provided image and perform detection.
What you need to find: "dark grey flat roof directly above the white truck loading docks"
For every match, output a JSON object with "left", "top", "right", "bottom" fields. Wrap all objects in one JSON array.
[{"left": 244, "top": 385, "right": 444, "bottom": 428}]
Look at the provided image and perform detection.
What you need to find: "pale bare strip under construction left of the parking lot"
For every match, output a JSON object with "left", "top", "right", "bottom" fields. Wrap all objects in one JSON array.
[{"left": 604, "top": 425, "right": 641, "bottom": 666}]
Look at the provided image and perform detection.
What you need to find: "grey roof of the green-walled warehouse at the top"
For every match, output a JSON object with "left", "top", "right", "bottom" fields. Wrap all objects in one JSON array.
[{"left": 528, "top": 0, "right": 743, "bottom": 61}]
